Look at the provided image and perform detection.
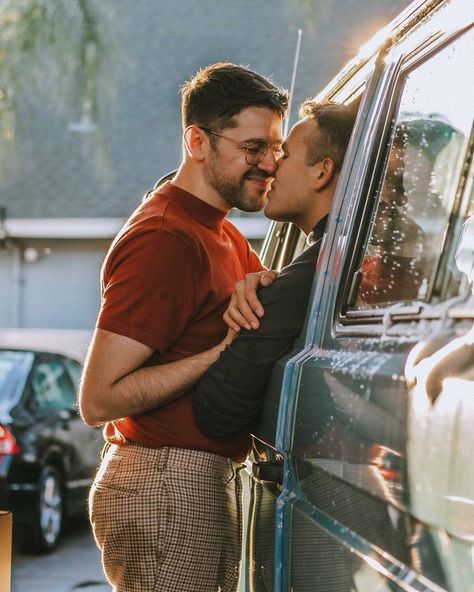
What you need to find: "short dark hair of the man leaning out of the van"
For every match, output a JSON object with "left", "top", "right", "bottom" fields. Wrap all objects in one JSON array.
[{"left": 299, "top": 100, "right": 360, "bottom": 170}]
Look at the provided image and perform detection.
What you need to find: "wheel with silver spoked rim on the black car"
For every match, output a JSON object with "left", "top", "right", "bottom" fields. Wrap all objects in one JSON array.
[{"left": 31, "top": 465, "right": 64, "bottom": 553}]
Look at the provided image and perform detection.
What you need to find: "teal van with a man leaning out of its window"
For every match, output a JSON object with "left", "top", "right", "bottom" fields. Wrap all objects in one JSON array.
[{"left": 243, "top": 0, "right": 474, "bottom": 592}]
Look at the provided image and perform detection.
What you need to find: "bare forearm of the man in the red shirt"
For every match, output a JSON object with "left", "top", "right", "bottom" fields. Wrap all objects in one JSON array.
[{"left": 80, "top": 342, "right": 225, "bottom": 425}]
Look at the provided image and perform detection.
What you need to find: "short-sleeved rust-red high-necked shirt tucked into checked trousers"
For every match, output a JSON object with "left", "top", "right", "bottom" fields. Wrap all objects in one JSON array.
[{"left": 97, "top": 183, "right": 263, "bottom": 461}]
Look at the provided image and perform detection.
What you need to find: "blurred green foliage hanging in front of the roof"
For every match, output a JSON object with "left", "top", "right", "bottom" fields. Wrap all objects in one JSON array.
[{"left": 0, "top": 0, "right": 117, "bottom": 180}]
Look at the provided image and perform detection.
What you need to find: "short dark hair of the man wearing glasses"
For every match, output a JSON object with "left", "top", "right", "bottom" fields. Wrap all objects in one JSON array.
[{"left": 181, "top": 63, "right": 288, "bottom": 131}]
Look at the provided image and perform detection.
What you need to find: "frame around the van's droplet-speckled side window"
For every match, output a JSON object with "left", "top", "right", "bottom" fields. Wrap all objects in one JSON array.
[{"left": 335, "top": 25, "right": 474, "bottom": 335}]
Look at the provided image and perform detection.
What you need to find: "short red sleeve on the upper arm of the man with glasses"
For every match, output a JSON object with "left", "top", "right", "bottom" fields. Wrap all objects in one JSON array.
[{"left": 97, "top": 230, "right": 196, "bottom": 353}]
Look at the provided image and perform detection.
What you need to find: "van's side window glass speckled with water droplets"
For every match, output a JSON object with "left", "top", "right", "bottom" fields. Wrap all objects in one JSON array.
[{"left": 355, "top": 31, "right": 474, "bottom": 309}]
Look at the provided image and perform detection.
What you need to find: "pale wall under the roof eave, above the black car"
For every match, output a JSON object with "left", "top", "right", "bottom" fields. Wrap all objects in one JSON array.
[{"left": 0, "top": 239, "right": 110, "bottom": 329}]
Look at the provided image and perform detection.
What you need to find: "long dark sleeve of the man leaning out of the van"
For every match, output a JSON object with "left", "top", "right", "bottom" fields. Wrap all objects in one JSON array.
[{"left": 193, "top": 244, "right": 316, "bottom": 437}]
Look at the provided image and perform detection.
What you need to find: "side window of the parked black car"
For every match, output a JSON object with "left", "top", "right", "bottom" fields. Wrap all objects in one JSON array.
[{"left": 32, "top": 360, "right": 76, "bottom": 409}]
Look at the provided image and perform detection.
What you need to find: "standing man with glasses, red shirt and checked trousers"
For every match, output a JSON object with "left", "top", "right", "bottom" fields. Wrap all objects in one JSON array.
[{"left": 80, "top": 64, "right": 288, "bottom": 592}]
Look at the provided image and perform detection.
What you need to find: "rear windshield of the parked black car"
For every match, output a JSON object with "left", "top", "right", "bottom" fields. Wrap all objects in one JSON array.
[{"left": 0, "top": 350, "right": 34, "bottom": 412}]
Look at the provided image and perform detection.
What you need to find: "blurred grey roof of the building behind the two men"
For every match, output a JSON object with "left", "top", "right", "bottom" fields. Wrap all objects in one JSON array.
[{"left": 0, "top": 0, "right": 409, "bottom": 227}]
